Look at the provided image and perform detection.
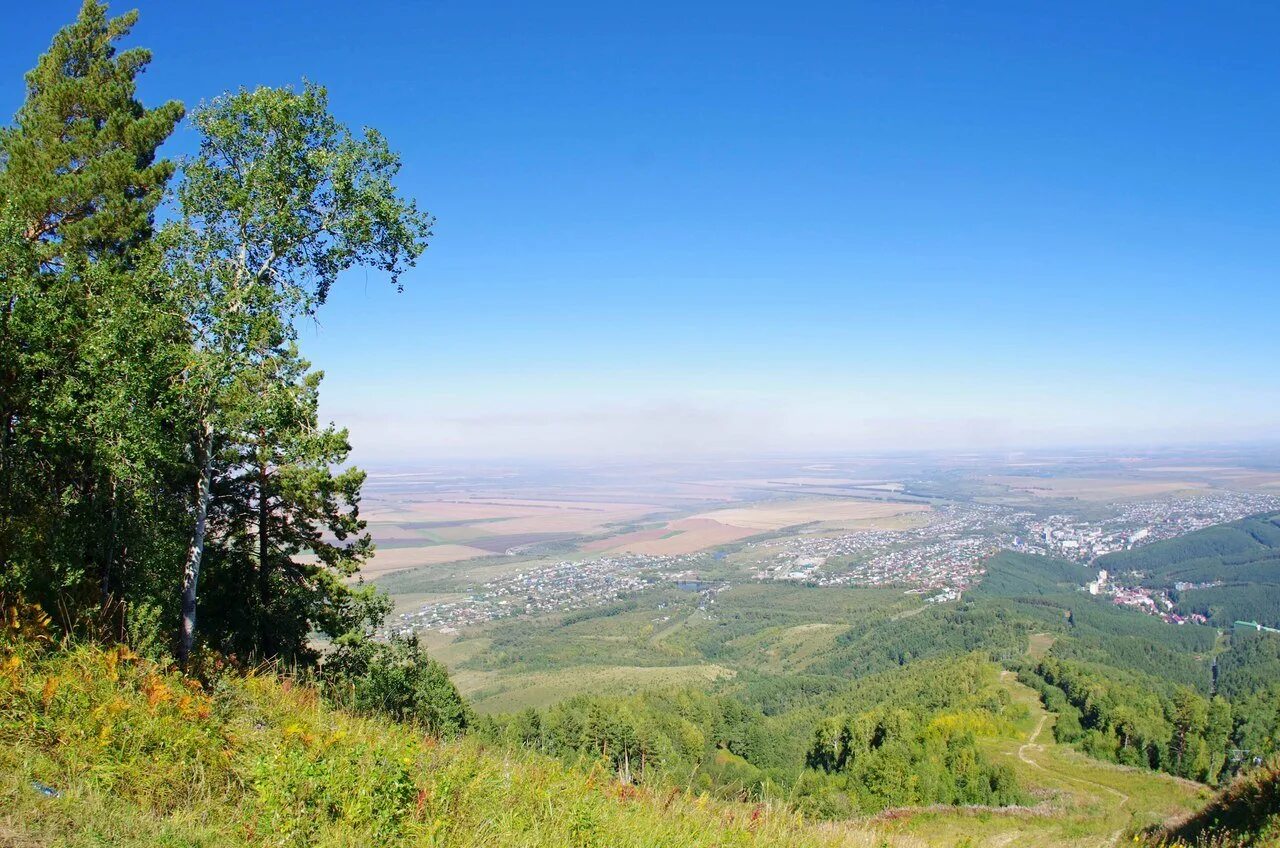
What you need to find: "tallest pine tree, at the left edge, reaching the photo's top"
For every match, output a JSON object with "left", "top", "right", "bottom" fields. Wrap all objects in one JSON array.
[{"left": 0, "top": 0, "right": 183, "bottom": 625}]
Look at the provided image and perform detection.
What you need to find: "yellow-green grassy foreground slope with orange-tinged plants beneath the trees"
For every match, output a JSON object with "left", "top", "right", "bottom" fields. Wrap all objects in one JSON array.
[{"left": 0, "top": 640, "right": 922, "bottom": 848}]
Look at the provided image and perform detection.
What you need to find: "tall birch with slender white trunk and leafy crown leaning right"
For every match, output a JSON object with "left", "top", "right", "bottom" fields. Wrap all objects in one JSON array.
[{"left": 164, "top": 83, "right": 431, "bottom": 661}]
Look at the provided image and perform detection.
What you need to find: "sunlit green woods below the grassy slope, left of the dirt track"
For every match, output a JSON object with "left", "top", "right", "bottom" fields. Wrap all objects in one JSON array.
[{"left": 477, "top": 656, "right": 1024, "bottom": 817}]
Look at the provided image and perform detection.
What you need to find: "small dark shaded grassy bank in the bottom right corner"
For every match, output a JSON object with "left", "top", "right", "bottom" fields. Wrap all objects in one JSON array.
[{"left": 1146, "top": 761, "right": 1280, "bottom": 848}]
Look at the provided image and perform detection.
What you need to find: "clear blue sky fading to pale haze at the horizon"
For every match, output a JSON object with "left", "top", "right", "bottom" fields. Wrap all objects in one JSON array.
[{"left": 0, "top": 0, "right": 1280, "bottom": 461}]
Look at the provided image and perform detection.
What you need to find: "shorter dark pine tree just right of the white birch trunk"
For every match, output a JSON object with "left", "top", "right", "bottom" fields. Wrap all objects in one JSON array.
[{"left": 202, "top": 346, "right": 372, "bottom": 662}]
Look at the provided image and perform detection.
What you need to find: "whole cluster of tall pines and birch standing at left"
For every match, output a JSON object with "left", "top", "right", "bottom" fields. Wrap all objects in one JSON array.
[{"left": 0, "top": 0, "right": 431, "bottom": 667}]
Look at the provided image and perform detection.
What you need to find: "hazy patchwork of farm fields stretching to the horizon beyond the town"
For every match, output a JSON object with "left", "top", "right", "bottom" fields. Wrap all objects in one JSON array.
[{"left": 362, "top": 453, "right": 1280, "bottom": 589}]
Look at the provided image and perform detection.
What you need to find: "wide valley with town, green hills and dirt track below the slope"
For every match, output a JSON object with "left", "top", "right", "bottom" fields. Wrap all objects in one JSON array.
[{"left": 353, "top": 457, "right": 1280, "bottom": 847}]
